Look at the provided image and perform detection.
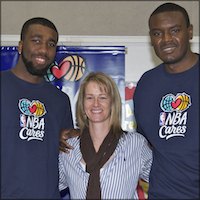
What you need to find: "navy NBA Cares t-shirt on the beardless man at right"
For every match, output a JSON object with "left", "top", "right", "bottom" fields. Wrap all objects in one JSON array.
[{"left": 133, "top": 57, "right": 200, "bottom": 199}]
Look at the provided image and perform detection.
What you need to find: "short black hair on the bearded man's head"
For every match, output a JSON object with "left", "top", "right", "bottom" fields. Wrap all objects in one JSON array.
[{"left": 20, "top": 17, "right": 58, "bottom": 42}]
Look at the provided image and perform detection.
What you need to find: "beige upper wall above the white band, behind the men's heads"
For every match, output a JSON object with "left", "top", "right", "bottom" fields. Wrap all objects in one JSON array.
[{"left": 0, "top": 0, "right": 199, "bottom": 36}]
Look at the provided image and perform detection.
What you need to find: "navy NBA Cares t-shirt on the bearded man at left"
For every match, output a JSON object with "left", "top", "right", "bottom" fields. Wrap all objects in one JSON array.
[{"left": 1, "top": 71, "right": 73, "bottom": 199}]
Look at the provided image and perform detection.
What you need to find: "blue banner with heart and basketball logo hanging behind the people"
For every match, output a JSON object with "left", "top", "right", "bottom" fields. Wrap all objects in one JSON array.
[{"left": 0, "top": 46, "right": 125, "bottom": 124}]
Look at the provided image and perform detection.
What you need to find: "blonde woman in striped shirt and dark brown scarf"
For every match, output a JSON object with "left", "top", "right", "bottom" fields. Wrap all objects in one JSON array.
[{"left": 59, "top": 72, "right": 152, "bottom": 199}]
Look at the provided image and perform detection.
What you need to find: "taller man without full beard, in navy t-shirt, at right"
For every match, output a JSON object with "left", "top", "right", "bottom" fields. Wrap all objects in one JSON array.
[{"left": 133, "top": 3, "right": 199, "bottom": 199}]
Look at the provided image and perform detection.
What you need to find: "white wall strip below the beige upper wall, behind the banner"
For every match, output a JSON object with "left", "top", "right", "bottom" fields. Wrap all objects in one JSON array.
[{"left": 1, "top": 35, "right": 199, "bottom": 82}]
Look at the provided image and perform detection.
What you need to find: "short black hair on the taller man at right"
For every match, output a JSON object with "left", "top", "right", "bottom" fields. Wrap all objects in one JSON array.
[{"left": 149, "top": 3, "right": 190, "bottom": 27}]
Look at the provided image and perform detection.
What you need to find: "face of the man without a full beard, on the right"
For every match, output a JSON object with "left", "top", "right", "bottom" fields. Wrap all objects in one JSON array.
[{"left": 149, "top": 11, "right": 193, "bottom": 64}]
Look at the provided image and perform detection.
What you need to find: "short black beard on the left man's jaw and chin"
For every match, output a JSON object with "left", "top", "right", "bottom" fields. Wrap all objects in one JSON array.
[{"left": 21, "top": 51, "right": 49, "bottom": 77}]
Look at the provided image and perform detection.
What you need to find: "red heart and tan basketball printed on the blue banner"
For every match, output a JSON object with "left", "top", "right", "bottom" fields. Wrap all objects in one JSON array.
[{"left": 51, "top": 55, "right": 86, "bottom": 81}]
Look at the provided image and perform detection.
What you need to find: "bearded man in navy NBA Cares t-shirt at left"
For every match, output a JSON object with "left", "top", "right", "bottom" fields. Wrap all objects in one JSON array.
[{"left": 1, "top": 18, "right": 73, "bottom": 199}]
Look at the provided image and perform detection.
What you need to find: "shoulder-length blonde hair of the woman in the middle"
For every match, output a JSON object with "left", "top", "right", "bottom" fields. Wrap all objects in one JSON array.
[{"left": 76, "top": 72, "right": 122, "bottom": 136}]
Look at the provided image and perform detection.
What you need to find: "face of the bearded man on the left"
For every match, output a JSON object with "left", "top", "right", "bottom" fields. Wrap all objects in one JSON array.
[{"left": 19, "top": 24, "right": 57, "bottom": 76}]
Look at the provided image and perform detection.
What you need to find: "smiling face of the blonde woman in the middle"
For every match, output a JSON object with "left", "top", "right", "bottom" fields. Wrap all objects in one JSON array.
[{"left": 84, "top": 81, "right": 111, "bottom": 125}]
